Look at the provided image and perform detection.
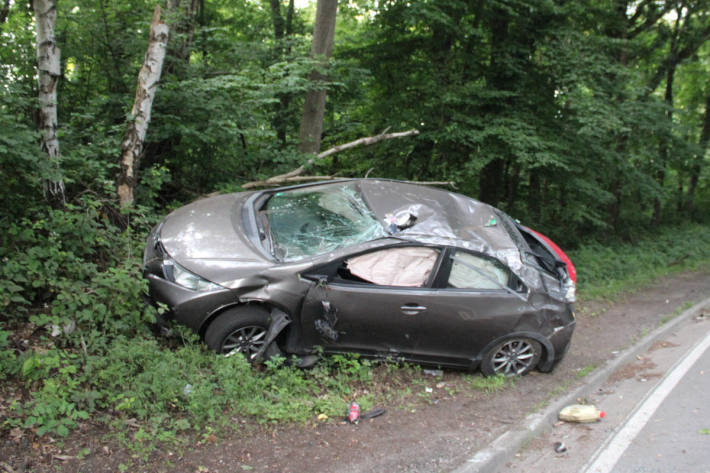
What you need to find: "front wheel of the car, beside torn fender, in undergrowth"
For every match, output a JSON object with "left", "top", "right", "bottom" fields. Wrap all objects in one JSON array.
[{"left": 205, "top": 307, "right": 281, "bottom": 363}]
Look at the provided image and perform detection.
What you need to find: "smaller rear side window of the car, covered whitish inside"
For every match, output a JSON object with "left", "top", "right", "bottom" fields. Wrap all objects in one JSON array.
[{"left": 448, "top": 251, "right": 509, "bottom": 289}]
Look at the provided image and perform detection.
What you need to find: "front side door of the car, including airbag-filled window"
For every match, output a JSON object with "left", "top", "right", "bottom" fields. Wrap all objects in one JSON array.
[{"left": 300, "top": 245, "right": 441, "bottom": 356}]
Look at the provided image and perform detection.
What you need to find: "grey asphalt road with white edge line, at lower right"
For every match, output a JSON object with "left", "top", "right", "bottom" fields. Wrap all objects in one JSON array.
[{"left": 498, "top": 310, "right": 710, "bottom": 473}]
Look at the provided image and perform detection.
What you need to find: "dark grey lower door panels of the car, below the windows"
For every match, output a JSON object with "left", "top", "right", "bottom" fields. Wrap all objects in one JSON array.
[{"left": 300, "top": 284, "right": 526, "bottom": 366}]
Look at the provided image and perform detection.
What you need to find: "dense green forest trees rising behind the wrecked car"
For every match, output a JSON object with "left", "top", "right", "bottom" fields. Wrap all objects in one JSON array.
[{"left": 0, "top": 0, "right": 710, "bottom": 245}]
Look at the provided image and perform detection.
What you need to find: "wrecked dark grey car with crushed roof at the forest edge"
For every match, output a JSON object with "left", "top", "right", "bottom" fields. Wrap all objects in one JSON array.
[{"left": 143, "top": 179, "right": 575, "bottom": 376}]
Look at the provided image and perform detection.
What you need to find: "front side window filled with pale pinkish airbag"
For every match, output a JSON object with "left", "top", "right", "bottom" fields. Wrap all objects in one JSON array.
[{"left": 346, "top": 247, "right": 439, "bottom": 287}]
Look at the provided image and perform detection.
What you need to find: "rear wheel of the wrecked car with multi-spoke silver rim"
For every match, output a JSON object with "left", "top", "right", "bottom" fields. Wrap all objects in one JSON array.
[{"left": 481, "top": 337, "right": 542, "bottom": 377}]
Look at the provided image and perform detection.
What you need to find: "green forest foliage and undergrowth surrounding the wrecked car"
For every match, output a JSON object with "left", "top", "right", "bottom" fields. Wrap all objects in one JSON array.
[{"left": 0, "top": 0, "right": 710, "bottom": 443}]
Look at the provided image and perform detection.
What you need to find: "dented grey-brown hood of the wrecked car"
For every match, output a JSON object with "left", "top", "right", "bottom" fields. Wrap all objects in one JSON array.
[{"left": 160, "top": 193, "right": 270, "bottom": 283}]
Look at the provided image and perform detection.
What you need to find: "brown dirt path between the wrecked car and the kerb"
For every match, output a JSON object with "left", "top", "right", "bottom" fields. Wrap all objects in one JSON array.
[{"left": 0, "top": 269, "right": 710, "bottom": 473}]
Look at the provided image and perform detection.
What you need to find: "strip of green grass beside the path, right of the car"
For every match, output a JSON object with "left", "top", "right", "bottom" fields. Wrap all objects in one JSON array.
[{"left": 569, "top": 224, "right": 710, "bottom": 299}]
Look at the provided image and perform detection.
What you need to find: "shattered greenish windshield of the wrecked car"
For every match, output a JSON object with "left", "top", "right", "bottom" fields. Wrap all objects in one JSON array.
[{"left": 262, "top": 183, "right": 387, "bottom": 261}]
